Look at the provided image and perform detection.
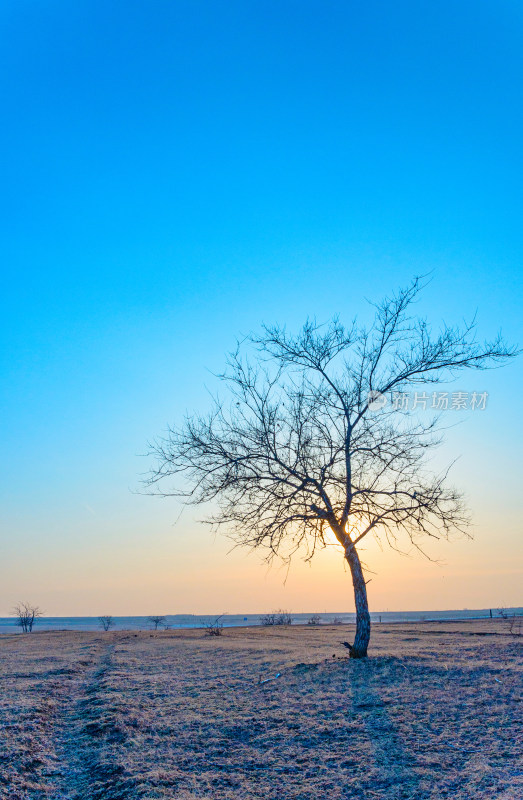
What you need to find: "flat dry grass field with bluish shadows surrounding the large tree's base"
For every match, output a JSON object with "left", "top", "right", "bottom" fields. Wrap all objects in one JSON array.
[{"left": 0, "top": 620, "right": 523, "bottom": 800}]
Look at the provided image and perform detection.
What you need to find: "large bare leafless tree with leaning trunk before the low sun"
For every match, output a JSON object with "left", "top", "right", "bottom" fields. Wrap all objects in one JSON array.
[{"left": 146, "top": 279, "right": 516, "bottom": 658}]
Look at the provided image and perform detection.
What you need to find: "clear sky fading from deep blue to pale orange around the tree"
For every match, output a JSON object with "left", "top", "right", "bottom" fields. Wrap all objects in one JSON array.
[{"left": 0, "top": 0, "right": 523, "bottom": 615}]
